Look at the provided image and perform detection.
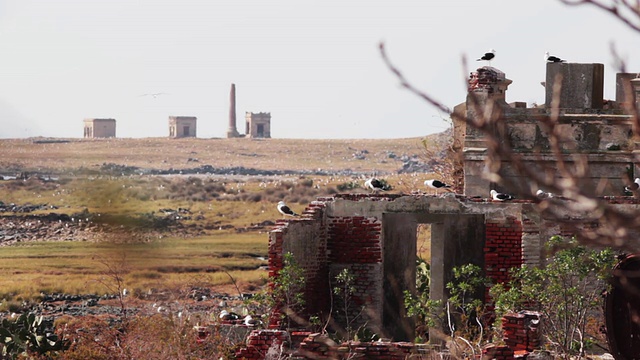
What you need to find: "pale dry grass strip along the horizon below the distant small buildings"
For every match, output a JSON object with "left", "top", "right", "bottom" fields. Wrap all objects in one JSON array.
[{"left": 0, "top": 137, "right": 435, "bottom": 173}]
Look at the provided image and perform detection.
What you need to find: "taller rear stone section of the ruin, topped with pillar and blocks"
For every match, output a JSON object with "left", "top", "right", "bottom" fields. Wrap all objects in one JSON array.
[{"left": 454, "top": 63, "right": 640, "bottom": 196}]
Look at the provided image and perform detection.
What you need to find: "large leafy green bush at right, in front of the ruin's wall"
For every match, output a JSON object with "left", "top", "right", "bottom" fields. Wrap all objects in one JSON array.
[{"left": 491, "top": 236, "right": 615, "bottom": 356}]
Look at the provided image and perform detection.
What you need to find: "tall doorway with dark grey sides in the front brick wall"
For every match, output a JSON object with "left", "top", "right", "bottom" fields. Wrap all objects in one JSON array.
[{"left": 382, "top": 213, "right": 485, "bottom": 341}]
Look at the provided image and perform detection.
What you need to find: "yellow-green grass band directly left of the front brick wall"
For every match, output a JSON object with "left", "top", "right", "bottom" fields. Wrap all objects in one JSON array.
[{"left": 0, "top": 233, "right": 268, "bottom": 301}]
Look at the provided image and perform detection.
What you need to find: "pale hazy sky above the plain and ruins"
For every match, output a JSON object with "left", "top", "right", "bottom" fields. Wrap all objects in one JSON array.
[{"left": 0, "top": 0, "right": 640, "bottom": 139}]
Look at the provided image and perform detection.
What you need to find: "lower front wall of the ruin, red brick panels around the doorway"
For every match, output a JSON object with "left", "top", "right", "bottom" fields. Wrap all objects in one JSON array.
[{"left": 269, "top": 194, "right": 528, "bottom": 340}]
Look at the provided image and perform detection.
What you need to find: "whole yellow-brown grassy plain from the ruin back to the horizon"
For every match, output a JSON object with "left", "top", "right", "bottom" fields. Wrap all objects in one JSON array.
[{"left": 0, "top": 135, "right": 446, "bottom": 310}]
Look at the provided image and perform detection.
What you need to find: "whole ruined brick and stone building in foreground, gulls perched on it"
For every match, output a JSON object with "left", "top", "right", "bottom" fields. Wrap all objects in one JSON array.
[{"left": 269, "top": 63, "right": 640, "bottom": 354}]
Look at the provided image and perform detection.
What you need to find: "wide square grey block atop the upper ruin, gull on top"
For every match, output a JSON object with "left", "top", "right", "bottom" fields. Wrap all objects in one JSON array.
[{"left": 545, "top": 63, "right": 604, "bottom": 109}]
